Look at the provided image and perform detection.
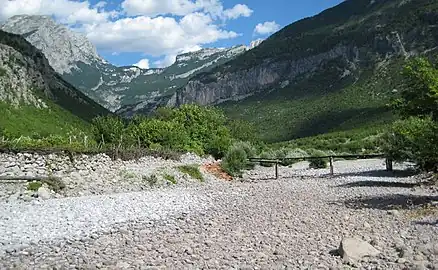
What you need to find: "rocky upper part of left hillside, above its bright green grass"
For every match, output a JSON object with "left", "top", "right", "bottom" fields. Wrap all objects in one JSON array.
[{"left": 0, "top": 31, "right": 108, "bottom": 120}]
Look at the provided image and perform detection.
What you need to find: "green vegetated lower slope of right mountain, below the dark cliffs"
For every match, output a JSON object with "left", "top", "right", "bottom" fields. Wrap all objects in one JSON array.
[{"left": 221, "top": 61, "right": 402, "bottom": 143}]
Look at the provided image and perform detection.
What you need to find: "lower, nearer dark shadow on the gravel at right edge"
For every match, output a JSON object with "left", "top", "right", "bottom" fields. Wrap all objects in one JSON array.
[{"left": 344, "top": 194, "right": 438, "bottom": 210}]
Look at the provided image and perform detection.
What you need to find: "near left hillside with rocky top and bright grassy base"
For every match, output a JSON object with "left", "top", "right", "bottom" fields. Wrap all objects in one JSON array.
[{"left": 0, "top": 31, "right": 109, "bottom": 137}]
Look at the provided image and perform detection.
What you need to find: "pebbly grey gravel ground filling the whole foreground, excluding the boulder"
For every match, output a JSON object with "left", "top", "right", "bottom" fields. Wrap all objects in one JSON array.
[{"left": 0, "top": 160, "right": 438, "bottom": 269}]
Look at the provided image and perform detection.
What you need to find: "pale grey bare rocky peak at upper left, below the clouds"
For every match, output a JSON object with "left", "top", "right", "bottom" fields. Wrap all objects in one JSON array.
[{"left": 0, "top": 15, "right": 104, "bottom": 74}]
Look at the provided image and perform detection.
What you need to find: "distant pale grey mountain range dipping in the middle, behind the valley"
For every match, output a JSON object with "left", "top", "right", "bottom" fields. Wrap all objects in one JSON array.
[{"left": 0, "top": 15, "right": 261, "bottom": 113}]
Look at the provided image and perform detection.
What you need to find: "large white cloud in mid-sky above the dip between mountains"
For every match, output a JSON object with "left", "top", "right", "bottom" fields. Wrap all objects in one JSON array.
[{"left": 85, "top": 13, "right": 238, "bottom": 56}]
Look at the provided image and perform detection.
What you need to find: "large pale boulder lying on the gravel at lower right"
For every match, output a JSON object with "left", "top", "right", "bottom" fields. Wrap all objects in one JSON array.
[{"left": 339, "top": 237, "right": 380, "bottom": 263}]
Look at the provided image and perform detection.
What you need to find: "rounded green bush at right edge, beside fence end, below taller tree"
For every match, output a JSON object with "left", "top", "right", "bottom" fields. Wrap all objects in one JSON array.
[{"left": 383, "top": 117, "right": 438, "bottom": 171}]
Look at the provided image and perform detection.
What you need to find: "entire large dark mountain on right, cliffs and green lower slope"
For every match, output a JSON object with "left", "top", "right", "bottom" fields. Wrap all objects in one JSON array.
[{"left": 161, "top": 0, "right": 438, "bottom": 142}]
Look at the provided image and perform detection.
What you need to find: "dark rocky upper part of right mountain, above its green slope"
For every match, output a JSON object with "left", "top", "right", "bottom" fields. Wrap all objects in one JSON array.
[{"left": 166, "top": 0, "right": 438, "bottom": 106}]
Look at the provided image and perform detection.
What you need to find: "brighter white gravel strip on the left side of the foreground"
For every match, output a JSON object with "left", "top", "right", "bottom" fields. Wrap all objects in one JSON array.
[{"left": 0, "top": 189, "right": 207, "bottom": 250}]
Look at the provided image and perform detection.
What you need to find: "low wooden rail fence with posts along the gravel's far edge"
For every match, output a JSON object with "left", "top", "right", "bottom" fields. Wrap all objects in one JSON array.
[{"left": 248, "top": 154, "right": 393, "bottom": 179}]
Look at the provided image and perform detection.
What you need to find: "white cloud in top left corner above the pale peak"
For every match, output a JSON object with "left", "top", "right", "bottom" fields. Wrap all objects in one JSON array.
[{"left": 0, "top": 0, "right": 115, "bottom": 24}]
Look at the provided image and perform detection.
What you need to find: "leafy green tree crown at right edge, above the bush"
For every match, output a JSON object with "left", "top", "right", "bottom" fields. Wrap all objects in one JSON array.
[{"left": 394, "top": 58, "right": 438, "bottom": 121}]
